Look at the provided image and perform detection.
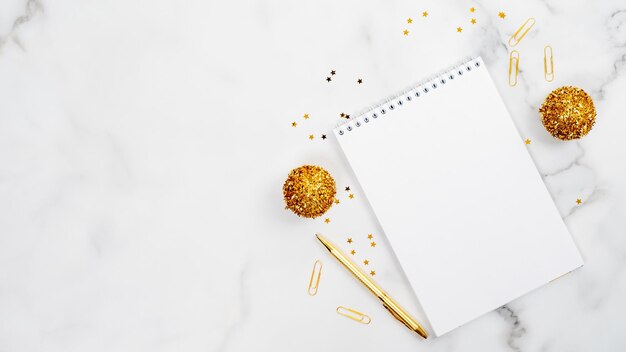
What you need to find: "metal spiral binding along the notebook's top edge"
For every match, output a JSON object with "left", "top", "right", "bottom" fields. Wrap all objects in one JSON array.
[{"left": 335, "top": 57, "right": 482, "bottom": 136}]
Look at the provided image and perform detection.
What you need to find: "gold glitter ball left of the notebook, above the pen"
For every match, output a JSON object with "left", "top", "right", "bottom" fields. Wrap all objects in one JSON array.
[{"left": 283, "top": 165, "right": 337, "bottom": 218}]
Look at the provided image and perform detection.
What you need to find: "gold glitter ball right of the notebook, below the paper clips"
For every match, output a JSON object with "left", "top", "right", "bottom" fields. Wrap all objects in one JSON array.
[{"left": 539, "top": 86, "right": 596, "bottom": 141}]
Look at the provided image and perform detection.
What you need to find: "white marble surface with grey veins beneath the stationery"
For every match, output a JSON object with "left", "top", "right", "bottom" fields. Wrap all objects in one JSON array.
[{"left": 0, "top": 0, "right": 626, "bottom": 352}]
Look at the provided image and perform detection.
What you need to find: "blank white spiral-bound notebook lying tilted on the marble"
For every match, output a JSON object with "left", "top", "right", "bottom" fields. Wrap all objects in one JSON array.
[{"left": 334, "top": 57, "right": 583, "bottom": 336}]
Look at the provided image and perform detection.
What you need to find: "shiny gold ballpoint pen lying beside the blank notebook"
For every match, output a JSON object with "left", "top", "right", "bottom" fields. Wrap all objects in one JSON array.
[{"left": 315, "top": 234, "right": 428, "bottom": 338}]
